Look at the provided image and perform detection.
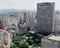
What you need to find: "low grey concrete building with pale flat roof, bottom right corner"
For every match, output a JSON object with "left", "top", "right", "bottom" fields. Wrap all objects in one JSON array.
[{"left": 41, "top": 34, "right": 60, "bottom": 48}]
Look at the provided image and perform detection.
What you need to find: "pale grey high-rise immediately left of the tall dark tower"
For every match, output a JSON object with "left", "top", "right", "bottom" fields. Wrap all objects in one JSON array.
[{"left": 29, "top": 12, "right": 36, "bottom": 30}]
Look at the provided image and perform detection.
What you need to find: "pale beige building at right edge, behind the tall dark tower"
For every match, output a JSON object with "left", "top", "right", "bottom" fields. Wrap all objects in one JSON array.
[{"left": 54, "top": 11, "right": 60, "bottom": 33}]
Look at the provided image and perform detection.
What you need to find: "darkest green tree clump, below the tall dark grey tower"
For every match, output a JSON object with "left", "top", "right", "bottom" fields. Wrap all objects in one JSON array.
[{"left": 27, "top": 33, "right": 42, "bottom": 45}]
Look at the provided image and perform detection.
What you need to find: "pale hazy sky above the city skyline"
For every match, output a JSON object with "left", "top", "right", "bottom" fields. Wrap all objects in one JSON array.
[{"left": 0, "top": 0, "right": 60, "bottom": 10}]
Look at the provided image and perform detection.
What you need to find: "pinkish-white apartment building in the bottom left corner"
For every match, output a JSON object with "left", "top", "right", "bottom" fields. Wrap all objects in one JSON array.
[{"left": 0, "top": 29, "right": 11, "bottom": 48}]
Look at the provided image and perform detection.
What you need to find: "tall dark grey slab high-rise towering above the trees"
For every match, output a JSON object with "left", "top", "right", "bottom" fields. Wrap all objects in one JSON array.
[{"left": 36, "top": 2, "right": 55, "bottom": 33}]
